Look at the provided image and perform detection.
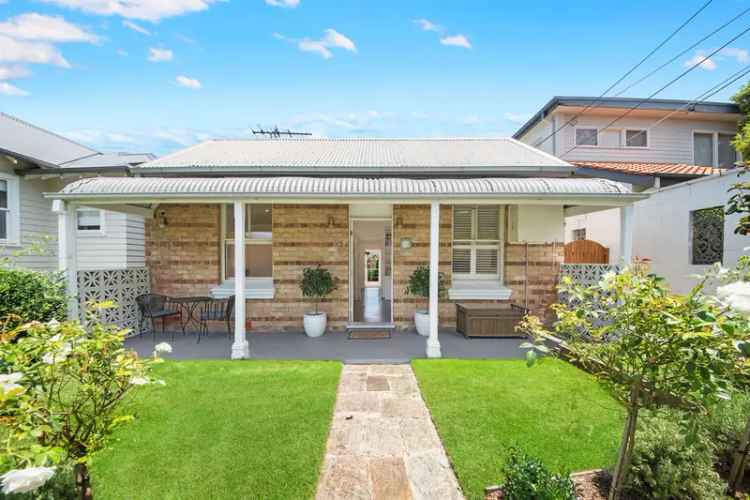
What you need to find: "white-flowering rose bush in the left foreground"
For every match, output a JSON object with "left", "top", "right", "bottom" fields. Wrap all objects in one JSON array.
[{"left": 0, "top": 310, "right": 171, "bottom": 499}]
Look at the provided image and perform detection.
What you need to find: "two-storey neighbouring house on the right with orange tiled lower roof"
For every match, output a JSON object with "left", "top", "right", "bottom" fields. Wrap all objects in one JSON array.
[{"left": 514, "top": 97, "right": 746, "bottom": 293}]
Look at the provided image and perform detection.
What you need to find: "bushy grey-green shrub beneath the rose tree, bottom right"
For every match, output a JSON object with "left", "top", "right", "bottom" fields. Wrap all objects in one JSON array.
[{"left": 625, "top": 410, "right": 727, "bottom": 500}]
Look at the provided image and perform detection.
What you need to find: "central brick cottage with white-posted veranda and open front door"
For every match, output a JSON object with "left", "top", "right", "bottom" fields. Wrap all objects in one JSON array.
[{"left": 49, "top": 138, "right": 647, "bottom": 358}]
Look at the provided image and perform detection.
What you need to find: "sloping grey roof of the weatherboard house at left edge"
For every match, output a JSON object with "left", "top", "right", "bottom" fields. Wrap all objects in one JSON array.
[{"left": 0, "top": 113, "right": 97, "bottom": 164}]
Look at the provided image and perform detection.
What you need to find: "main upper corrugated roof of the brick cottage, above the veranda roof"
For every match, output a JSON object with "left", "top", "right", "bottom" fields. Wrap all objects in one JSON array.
[{"left": 138, "top": 137, "right": 572, "bottom": 173}]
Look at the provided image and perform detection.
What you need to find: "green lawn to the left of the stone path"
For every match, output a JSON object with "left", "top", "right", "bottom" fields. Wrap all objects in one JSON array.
[{"left": 92, "top": 361, "right": 341, "bottom": 500}]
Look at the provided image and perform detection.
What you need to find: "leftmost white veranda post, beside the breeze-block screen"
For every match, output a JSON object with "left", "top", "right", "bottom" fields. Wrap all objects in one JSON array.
[{"left": 52, "top": 200, "right": 80, "bottom": 320}]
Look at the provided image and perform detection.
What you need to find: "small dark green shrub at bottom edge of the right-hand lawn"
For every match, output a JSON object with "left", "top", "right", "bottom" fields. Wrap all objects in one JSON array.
[{"left": 503, "top": 448, "right": 576, "bottom": 500}]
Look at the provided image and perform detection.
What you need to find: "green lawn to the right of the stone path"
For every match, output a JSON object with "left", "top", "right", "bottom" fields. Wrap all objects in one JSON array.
[{"left": 412, "top": 359, "right": 624, "bottom": 499}]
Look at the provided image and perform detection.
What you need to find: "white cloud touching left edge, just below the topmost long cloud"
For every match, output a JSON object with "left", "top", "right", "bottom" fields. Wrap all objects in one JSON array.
[{"left": 0, "top": 12, "right": 99, "bottom": 43}]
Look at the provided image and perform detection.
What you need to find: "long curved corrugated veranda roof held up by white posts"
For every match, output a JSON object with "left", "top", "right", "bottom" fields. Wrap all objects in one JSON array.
[{"left": 54, "top": 177, "right": 632, "bottom": 199}]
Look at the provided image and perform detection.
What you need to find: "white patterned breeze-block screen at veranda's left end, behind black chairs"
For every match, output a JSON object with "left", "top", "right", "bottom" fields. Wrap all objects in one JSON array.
[{"left": 78, "top": 267, "right": 151, "bottom": 332}]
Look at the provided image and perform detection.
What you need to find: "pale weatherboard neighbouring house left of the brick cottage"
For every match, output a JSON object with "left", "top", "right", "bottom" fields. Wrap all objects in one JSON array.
[{"left": 0, "top": 113, "right": 154, "bottom": 271}]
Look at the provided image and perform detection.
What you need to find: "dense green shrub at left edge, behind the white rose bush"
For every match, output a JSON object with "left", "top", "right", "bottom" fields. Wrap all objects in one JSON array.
[{"left": 0, "top": 266, "right": 67, "bottom": 328}]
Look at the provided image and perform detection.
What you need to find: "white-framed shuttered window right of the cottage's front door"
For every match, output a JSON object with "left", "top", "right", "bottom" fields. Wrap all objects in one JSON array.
[{"left": 453, "top": 205, "right": 502, "bottom": 279}]
